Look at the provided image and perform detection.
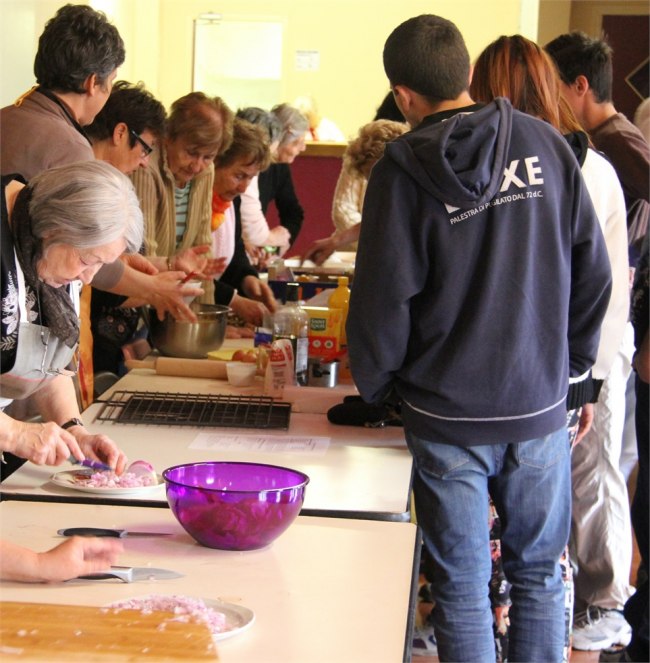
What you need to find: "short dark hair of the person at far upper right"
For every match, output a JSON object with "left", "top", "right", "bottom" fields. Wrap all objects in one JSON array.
[{"left": 544, "top": 31, "right": 613, "bottom": 103}]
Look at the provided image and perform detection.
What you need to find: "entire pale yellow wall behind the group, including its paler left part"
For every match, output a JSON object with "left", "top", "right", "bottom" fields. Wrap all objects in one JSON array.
[{"left": 0, "top": 0, "right": 539, "bottom": 136}]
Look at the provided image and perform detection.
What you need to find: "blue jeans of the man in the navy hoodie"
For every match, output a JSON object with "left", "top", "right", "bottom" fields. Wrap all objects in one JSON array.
[{"left": 406, "top": 427, "right": 571, "bottom": 663}]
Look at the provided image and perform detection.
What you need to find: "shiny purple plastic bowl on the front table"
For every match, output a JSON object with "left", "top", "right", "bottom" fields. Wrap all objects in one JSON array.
[{"left": 163, "top": 462, "right": 309, "bottom": 550}]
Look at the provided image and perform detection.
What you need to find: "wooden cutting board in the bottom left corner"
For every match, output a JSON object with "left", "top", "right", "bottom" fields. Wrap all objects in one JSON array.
[{"left": 0, "top": 601, "right": 218, "bottom": 663}]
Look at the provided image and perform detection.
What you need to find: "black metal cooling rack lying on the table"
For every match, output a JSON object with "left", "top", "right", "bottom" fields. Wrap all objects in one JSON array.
[{"left": 96, "top": 391, "right": 291, "bottom": 430}]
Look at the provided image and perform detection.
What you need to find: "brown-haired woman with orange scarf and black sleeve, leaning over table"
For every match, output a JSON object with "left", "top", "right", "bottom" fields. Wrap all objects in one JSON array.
[{"left": 212, "top": 118, "right": 276, "bottom": 325}]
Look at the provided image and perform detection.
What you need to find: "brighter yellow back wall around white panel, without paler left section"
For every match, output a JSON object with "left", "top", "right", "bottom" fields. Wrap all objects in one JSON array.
[{"left": 159, "top": 0, "right": 521, "bottom": 136}]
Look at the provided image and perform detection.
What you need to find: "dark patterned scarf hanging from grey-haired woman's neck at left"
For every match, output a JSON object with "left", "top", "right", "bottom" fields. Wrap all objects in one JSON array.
[{"left": 11, "top": 186, "right": 79, "bottom": 348}]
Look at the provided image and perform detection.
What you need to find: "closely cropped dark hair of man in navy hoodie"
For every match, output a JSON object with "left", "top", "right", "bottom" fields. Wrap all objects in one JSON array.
[{"left": 384, "top": 14, "right": 470, "bottom": 101}]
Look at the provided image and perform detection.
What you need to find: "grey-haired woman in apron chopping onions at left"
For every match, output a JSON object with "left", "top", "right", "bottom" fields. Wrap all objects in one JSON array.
[{"left": 0, "top": 161, "right": 142, "bottom": 480}]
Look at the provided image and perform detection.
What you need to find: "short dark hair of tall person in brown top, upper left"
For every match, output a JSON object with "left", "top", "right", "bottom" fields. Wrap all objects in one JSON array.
[{"left": 34, "top": 5, "right": 125, "bottom": 94}]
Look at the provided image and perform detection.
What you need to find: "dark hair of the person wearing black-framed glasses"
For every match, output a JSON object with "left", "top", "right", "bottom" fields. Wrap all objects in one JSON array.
[{"left": 85, "top": 81, "right": 165, "bottom": 147}]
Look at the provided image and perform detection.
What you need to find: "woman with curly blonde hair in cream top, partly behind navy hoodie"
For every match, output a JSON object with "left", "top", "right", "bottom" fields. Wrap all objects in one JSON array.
[{"left": 303, "top": 120, "right": 409, "bottom": 265}]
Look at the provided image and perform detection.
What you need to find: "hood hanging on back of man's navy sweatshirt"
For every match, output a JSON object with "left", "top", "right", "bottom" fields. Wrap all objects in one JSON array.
[{"left": 385, "top": 97, "right": 513, "bottom": 209}]
